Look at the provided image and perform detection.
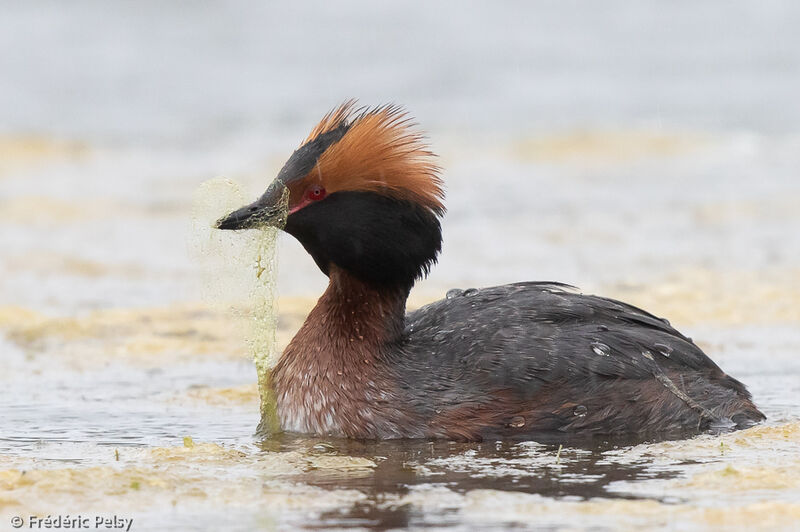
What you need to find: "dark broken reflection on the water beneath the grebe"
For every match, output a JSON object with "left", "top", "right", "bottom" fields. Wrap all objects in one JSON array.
[{"left": 268, "top": 435, "right": 680, "bottom": 528}]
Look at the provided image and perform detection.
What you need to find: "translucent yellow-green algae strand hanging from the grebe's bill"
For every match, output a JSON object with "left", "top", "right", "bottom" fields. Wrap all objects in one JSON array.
[{"left": 193, "top": 178, "right": 289, "bottom": 434}]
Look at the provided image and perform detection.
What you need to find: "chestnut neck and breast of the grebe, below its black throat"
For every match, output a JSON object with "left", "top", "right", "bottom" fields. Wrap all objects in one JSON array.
[{"left": 271, "top": 265, "right": 410, "bottom": 437}]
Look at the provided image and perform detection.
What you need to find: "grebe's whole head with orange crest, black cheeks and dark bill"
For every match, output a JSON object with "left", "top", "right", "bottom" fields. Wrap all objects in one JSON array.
[{"left": 217, "top": 101, "right": 445, "bottom": 287}]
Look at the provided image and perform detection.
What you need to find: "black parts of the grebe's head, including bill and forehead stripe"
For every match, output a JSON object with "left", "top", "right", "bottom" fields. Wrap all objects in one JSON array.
[{"left": 217, "top": 120, "right": 442, "bottom": 289}]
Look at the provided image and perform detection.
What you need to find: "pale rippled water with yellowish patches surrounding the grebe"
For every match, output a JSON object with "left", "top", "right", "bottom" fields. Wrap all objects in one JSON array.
[{"left": 0, "top": 1, "right": 800, "bottom": 530}]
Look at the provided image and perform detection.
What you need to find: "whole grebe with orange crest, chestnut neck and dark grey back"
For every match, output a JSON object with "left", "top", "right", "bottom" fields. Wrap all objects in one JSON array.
[{"left": 217, "top": 101, "right": 765, "bottom": 440}]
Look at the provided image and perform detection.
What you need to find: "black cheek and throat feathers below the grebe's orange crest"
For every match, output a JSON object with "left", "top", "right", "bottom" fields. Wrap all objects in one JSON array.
[{"left": 284, "top": 191, "right": 442, "bottom": 289}]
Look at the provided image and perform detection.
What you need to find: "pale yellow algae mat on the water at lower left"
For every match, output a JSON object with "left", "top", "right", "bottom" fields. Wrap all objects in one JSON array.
[{"left": 0, "top": 438, "right": 374, "bottom": 515}]
